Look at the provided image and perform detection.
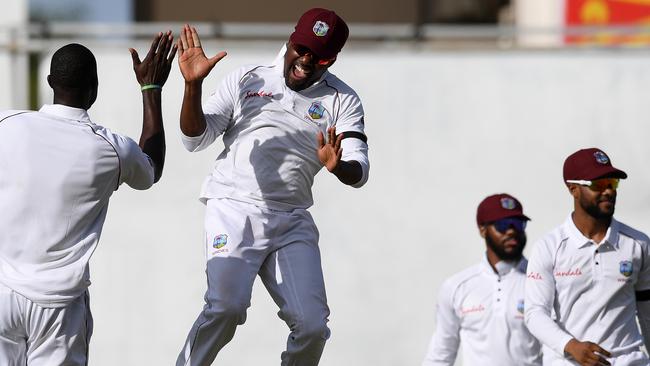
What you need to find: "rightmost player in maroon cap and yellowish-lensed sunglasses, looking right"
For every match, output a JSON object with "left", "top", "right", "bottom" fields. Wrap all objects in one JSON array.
[{"left": 526, "top": 148, "right": 650, "bottom": 366}]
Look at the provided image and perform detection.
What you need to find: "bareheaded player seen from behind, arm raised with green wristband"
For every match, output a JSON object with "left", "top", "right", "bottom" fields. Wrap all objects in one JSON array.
[{"left": 0, "top": 32, "right": 176, "bottom": 366}]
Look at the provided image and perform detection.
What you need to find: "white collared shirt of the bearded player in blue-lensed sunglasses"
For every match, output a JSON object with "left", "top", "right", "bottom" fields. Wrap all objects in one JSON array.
[{"left": 423, "top": 258, "right": 542, "bottom": 366}]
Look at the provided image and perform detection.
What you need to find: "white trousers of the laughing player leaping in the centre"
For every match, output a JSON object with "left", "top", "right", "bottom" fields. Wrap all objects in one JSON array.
[{"left": 176, "top": 199, "right": 330, "bottom": 366}]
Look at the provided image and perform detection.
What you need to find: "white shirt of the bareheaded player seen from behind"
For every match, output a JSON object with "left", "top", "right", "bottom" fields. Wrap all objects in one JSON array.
[{"left": 0, "top": 104, "right": 153, "bottom": 307}]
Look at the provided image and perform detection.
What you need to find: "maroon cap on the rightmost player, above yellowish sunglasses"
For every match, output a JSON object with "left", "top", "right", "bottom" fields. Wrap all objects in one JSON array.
[{"left": 563, "top": 147, "right": 627, "bottom": 181}]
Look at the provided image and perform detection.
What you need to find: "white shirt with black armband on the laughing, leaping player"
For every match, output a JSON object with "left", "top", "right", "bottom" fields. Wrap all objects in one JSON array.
[{"left": 183, "top": 45, "right": 369, "bottom": 210}]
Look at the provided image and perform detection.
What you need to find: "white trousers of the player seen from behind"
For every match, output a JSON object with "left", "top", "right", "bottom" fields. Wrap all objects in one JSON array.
[{"left": 0, "top": 283, "right": 93, "bottom": 366}]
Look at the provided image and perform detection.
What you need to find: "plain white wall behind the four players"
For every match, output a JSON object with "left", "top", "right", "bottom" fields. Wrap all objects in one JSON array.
[{"left": 34, "top": 42, "right": 650, "bottom": 366}]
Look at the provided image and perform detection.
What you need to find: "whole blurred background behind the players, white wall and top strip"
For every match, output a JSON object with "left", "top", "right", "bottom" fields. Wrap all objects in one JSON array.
[{"left": 0, "top": 0, "right": 650, "bottom": 366}]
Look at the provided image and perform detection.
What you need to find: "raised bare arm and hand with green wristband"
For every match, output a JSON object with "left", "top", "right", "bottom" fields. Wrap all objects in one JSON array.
[{"left": 129, "top": 31, "right": 177, "bottom": 182}]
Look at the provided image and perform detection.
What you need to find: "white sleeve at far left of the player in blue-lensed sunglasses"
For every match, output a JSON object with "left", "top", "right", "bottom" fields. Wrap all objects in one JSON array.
[{"left": 422, "top": 281, "right": 460, "bottom": 366}]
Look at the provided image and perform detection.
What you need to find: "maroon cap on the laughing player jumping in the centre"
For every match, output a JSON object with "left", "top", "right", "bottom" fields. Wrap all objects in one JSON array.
[{"left": 289, "top": 8, "right": 349, "bottom": 59}]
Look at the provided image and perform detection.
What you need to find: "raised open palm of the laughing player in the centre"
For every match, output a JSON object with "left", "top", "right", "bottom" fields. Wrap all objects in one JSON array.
[{"left": 178, "top": 24, "right": 226, "bottom": 82}]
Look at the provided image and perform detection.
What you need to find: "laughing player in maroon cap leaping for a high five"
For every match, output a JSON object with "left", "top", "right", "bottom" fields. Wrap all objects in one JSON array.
[{"left": 176, "top": 8, "right": 369, "bottom": 366}]
